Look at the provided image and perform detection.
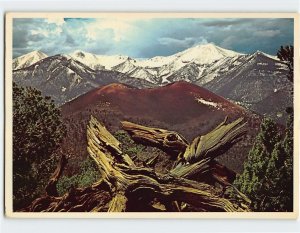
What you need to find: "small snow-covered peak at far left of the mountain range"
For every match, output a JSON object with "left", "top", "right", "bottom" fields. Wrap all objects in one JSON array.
[{"left": 12, "top": 51, "right": 48, "bottom": 70}]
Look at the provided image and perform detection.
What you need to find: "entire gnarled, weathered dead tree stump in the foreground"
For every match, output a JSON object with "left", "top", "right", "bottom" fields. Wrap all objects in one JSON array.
[{"left": 22, "top": 117, "right": 249, "bottom": 212}]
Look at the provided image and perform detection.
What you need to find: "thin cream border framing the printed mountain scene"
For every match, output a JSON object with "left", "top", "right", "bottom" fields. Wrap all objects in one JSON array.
[{"left": 5, "top": 12, "right": 300, "bottom": 219}]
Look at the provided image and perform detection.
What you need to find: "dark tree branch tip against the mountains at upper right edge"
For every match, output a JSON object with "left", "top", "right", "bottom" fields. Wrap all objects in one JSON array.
[{"left": 277, "top": 45, "right": 294, "bottom": 82}]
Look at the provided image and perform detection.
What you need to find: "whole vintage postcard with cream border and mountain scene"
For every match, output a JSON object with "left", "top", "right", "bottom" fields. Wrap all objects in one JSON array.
[{"left": 5, "top": 12, "right": 299, "bottom": 219}]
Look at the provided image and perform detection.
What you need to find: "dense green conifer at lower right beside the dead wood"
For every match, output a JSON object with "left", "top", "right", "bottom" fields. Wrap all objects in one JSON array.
[{"left": 234, "top": 116, "right": 293, "bottom": 211}]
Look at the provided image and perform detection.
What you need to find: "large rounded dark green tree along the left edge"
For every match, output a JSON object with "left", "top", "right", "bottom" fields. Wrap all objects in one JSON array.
[{"left": 13, "top": 83, "right": 65, "bottom": 210}]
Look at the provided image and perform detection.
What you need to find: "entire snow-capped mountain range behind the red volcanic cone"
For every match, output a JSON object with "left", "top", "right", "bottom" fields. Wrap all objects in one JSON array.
[{"left": 13, "top": 44, "right": 292, "bottom": 122}]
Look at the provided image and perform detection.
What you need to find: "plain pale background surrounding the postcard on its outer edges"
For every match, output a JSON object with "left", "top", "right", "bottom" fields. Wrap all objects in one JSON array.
[{"left": 0, "top": 0, "right": 300, "bottom": 233}]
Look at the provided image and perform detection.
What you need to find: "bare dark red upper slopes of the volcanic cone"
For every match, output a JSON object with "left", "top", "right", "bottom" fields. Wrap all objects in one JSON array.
[{"left": 62, "top": 81, "right": 245, "bottom": 124}]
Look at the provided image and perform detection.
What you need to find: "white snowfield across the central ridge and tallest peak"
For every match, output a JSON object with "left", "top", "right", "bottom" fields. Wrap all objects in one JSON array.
[{"left": 65, "top": 44, "right": 242, "bottom": 84}]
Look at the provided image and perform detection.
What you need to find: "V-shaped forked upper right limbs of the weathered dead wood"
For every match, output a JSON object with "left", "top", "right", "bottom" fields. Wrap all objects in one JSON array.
[{"left": 121, "top": 117, "right": 246, "bottom": 186}]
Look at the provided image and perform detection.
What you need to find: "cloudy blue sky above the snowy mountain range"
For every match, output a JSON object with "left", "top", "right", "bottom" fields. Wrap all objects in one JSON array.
[{"left": 13, "top": 18, "right": 294, "bottom": 58}]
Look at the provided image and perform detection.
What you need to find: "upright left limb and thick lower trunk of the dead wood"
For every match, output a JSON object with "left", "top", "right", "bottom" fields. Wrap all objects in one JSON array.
[{"left": 88, "top": 115, "right": 248, "bottom": 211}]
